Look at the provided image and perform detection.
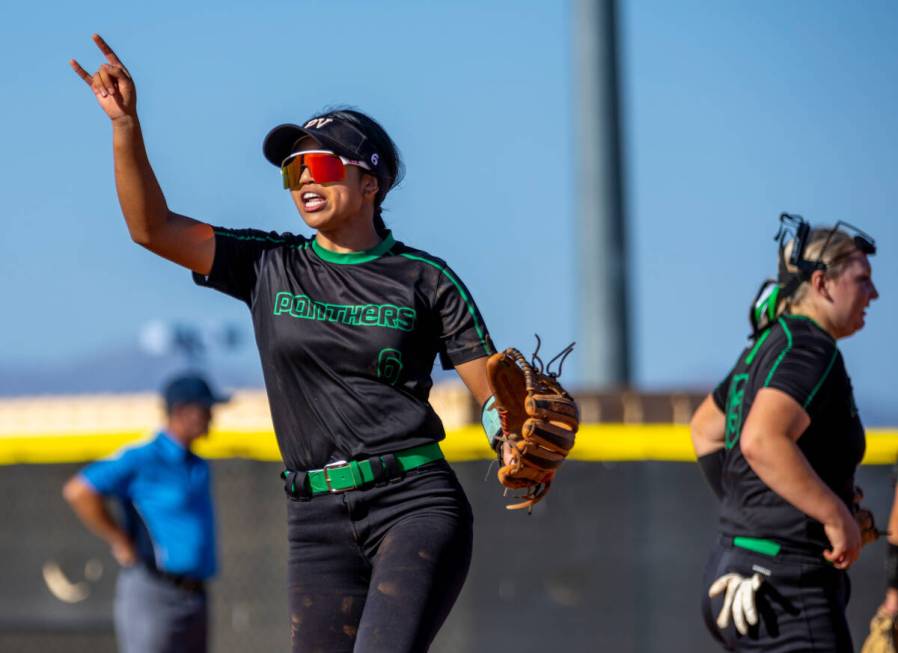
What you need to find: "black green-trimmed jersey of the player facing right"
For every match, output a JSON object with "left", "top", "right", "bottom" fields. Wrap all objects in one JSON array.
[{"left": 713, "top": 315, "right": 866, "bottom": 550}]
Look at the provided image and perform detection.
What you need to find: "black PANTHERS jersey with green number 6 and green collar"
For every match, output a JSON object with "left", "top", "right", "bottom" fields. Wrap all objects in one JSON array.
[{"left": 194, "top": 227, "right": 495, "bottom": 470}]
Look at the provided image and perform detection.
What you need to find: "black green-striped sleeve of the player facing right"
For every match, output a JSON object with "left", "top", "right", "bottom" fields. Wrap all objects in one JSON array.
[{"left": 763, "top": 333, "right": 839, "bottom": 408}]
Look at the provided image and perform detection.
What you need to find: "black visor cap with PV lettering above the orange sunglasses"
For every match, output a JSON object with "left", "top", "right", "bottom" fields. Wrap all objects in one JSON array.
[{"left": 262, "top": 112, "right": 388, "bottom": 177}]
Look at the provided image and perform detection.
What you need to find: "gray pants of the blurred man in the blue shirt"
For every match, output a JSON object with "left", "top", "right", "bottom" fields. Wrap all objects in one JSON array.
[{"left": 115, "top": 565, "right": 208, "bottom": 653}]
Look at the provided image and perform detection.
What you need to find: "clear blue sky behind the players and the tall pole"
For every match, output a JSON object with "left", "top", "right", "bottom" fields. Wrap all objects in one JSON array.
[{"left": 0, "top": 0, "right": 898, "bottom": 418}]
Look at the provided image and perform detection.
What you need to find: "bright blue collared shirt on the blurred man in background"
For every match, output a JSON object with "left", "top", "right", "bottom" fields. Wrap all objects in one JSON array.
[{"left": 81, "top": 431, "right": 218, "bottom": 579}]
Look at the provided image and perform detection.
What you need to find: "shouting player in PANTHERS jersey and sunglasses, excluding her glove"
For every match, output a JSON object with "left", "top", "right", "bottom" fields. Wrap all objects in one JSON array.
[{"left": 72, "top": 36, "right": 504, "bottom": 653}]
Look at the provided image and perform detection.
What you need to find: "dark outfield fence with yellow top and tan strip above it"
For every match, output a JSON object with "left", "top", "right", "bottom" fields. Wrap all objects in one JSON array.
[{"left": 0, "top": 393, "right": 898, "bottom": 653}]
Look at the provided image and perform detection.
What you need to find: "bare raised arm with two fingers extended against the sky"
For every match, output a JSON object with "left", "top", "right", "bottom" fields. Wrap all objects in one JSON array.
[{"left": 70, "top": 34, "right": 215, "bottom": 275}]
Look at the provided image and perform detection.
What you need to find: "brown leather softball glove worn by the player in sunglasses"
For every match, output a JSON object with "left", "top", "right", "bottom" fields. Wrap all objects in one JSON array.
[{"left": 487, "top": 338, "right": 580, "bottom": 510}]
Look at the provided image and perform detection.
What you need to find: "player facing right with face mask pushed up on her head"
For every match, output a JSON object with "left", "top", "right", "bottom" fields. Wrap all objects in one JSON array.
[{"left": 691, "top": 216, "right": 878, "bottom": 653}]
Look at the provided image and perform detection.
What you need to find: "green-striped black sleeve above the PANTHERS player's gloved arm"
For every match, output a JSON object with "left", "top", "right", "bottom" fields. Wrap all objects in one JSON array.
[{"left": 434, "top": 266, "right": 496, "bottom": 370}]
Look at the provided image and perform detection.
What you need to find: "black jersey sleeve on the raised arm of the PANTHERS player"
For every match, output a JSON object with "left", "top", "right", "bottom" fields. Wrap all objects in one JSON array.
[{"left": 193, "top": 227, "right": 304, "bottom": 306}]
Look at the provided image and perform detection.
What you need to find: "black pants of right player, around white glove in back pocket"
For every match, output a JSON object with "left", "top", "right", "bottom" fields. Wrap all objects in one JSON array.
[{"left": 702, "top": 539, "right": 854, "bottom": 653}]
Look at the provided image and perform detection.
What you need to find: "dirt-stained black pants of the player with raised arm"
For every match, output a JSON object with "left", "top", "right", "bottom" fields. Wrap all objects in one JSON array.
[{"left": 287, "top": 460, "right": 473, "bottom": 653}]
